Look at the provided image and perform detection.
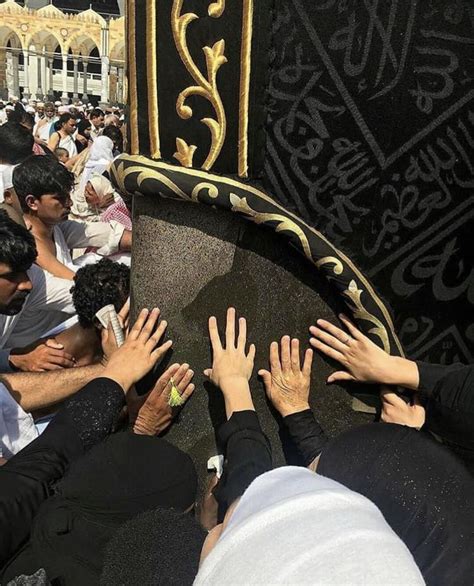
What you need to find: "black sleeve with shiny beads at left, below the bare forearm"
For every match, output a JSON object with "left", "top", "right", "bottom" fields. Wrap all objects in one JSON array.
[{"left": 0, "top": 378, "right": 124, "bottom": 567}]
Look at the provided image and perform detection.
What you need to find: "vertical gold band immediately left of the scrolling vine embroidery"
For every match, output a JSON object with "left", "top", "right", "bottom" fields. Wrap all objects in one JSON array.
[{"left": 146, "top": 0, "right": 161, "bottom": 159}]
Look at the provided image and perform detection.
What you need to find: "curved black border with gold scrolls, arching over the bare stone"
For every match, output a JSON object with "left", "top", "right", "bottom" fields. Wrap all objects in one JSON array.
[{"left": 111, "top": 155, "right": 404, "bottom": 356}]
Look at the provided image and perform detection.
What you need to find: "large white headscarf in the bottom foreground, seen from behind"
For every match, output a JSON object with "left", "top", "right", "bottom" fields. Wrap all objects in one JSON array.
[{"left": 194, "top": 466, "right": 425, "bottom": 586}]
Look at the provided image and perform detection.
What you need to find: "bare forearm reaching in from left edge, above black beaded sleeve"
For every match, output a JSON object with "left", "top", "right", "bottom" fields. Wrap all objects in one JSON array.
[{"left": 0, "top": 364, "right": 104, "bottom": 412}]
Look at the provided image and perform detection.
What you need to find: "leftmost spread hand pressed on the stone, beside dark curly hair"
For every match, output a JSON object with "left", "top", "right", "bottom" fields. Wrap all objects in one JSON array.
[{"left": 103, "top": 308, "right": 173, "bottom": 392}]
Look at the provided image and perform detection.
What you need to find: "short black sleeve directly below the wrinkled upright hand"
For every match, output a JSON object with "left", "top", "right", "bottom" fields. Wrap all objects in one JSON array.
[{"left": 283, "top": 409, "right": 328, "bottom": 466}]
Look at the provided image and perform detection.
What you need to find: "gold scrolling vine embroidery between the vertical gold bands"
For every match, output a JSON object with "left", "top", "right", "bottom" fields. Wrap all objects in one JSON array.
[{"left": 171, "top": 0, "right": 227, "bottom": 170}]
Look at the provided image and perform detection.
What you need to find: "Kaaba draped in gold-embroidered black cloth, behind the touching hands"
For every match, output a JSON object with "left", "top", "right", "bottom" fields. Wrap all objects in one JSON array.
[{"left": 112, "top": 0, "right": 474, "bottom": 480}]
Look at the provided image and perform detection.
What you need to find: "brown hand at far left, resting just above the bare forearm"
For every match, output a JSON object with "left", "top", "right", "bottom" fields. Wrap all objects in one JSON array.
[{"left": 9, "top": 338, "right": 76, "bottom": 372}]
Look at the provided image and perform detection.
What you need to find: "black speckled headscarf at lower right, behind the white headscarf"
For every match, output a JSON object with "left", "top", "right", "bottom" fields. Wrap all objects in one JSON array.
[{"left": 318, "top": 423, "right": 474, "bottom": 585}]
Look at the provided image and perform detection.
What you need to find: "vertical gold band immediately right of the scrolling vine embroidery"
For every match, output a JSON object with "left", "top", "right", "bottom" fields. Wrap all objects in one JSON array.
[{"left": 238, "top": 0, "right": 253, "bottom": 177}]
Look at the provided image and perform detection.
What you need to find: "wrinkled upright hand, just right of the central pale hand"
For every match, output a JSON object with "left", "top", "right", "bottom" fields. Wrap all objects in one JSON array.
[{"left": 258, "top": 336, "right": 313, "bottom": 417}]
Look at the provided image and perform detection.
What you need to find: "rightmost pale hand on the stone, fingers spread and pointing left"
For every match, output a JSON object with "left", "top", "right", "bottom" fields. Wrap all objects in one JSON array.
[{"left": 309, "top": 314, "right": 419, "bottom": 389}]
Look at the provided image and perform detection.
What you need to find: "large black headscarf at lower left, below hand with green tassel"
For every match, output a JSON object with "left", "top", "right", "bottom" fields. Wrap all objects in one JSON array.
[{"left": 4, "top": 432, "right": 197, "bottom": 585}]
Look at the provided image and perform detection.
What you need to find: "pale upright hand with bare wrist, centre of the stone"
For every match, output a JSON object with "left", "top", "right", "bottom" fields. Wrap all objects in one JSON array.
[{"left": 204, "top": 307, "right": 255, "bottom": 418}]
